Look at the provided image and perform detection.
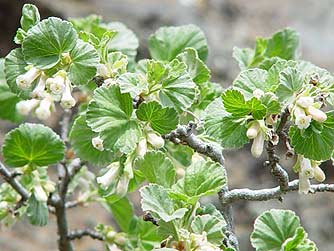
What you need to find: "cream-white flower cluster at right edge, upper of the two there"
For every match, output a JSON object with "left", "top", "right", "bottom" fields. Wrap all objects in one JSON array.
[{"left": 289, "top": 96, "right": 327, "bottom": 129}]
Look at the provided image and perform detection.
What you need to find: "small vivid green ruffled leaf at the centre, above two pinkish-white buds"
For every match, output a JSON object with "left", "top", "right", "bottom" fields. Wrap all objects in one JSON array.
[{"left": 136, "top": 101, "right": 179, "bottom": 134}]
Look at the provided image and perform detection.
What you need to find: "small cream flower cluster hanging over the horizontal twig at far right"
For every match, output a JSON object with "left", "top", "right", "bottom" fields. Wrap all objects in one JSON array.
[{"left": 294, "top": 155, "right": 326, "bottom": 194}]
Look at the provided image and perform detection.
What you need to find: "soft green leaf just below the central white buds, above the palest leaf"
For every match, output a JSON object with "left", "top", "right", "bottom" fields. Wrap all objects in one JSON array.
[{"left": 135, "top": 151, "right": 176, "bottom": 188}]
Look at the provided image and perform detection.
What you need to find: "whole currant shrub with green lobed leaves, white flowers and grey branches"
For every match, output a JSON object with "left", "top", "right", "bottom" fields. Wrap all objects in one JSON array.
[{"left": 0, "top": 4, "right": 334, "bottom": 251}]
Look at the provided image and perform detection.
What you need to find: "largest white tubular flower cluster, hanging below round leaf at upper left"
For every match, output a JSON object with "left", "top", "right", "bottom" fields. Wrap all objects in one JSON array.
[{"left": 16, "top": 66, "right": 76, "bottom": 120}]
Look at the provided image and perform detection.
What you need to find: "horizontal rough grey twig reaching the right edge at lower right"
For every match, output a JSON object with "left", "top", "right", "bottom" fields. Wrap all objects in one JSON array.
[{"left": 223, "top": 180, "right": 334, "bottom": 204}]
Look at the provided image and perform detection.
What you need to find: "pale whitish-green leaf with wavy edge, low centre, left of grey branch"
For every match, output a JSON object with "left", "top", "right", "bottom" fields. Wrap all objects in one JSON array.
[{"left": 139, "top": 184, "right": 188, "bottom": 222}]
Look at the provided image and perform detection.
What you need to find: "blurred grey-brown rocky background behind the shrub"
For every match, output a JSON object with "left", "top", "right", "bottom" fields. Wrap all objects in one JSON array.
[{"left": 0, "top": 0, "right": 334, "bottom": 251}]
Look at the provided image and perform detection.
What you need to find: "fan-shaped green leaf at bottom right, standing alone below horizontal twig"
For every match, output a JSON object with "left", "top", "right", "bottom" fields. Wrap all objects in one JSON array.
[{"left": 251, "top": 209, "right": 300, "bottom": 251}]
